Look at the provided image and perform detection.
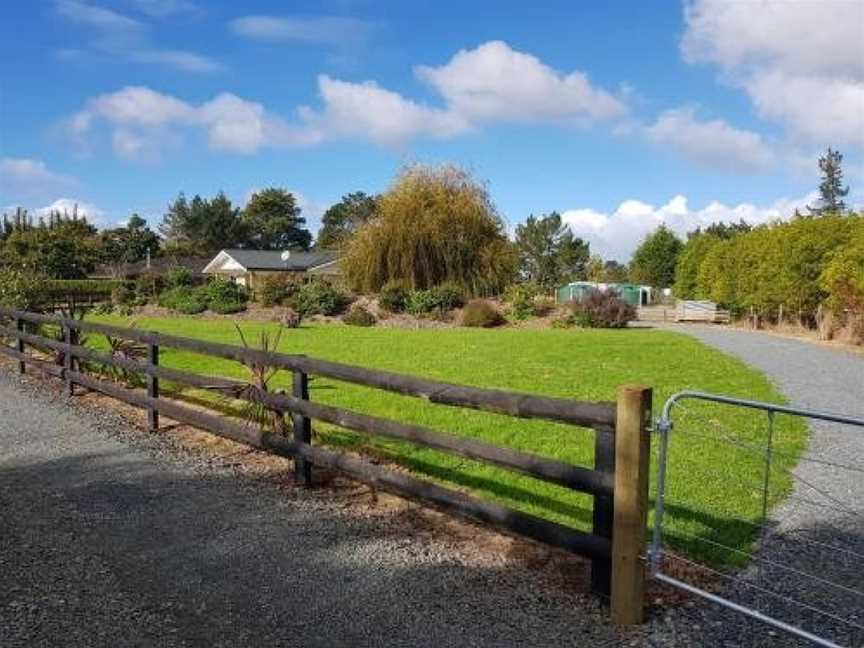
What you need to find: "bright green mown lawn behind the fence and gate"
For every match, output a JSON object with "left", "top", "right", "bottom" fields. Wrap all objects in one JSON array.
[{"left": 90, "top": 317, "right": 806, "bottom": 563}]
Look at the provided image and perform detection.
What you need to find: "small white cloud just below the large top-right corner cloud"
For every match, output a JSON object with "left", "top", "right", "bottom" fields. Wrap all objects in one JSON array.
[{"left": 644, "top": 107, "right": 775, "bottom": 171}]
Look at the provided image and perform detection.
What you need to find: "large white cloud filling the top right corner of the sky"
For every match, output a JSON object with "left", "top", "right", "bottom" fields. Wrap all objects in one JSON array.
[{"left": 681, "top": 0, "right": 864, "bottom": 147}]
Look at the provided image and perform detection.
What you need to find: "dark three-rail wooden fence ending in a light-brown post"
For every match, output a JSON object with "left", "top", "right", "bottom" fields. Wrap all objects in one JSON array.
[{"left": 0, "top": 308, "right": 651, "bottom": 625}]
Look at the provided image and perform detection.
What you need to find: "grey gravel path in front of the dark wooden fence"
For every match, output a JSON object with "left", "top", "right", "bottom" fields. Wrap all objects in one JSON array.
[{"left": 0, "top": 367, "right": 624, "bottom": 648}]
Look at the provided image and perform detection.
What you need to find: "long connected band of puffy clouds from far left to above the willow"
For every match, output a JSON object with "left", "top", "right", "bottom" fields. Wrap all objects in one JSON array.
[{"left": 67, "top": 41, "right": 626, "bottom": 158}]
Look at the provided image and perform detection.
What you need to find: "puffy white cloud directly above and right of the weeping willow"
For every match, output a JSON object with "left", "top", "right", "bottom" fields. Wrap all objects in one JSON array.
[{"left": 415, "top": 41, "right": 626, "bottom": 123}]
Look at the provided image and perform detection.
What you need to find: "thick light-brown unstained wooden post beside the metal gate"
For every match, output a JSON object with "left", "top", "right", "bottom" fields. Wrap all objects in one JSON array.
[{"left": 611, "top": 385, "right": 652, "bottom": 625}]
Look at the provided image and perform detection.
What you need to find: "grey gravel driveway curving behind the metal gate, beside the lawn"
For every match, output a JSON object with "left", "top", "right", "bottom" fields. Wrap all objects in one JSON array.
[{"left": 656, "top": 325, "right": 864, "bottom": 647}]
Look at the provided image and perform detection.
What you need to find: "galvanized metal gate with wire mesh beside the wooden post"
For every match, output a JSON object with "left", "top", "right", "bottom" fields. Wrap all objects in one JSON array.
[{"left": 649, "top": 385, "right": 864, "bottom": 647}]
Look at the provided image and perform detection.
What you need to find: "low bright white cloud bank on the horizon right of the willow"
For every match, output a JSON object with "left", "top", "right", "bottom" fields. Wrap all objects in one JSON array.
[{"left": 561, "top": 193, "right": 816, "bottom": 261}]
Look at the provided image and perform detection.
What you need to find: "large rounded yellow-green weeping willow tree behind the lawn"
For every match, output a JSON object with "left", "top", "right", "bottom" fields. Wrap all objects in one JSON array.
[{"left": 342, "top": 165, "right": 518, "bottom": 295}]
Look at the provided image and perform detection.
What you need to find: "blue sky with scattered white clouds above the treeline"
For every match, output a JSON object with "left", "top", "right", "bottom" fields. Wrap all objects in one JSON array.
[{"left": 0, "top": 0, "right": 864, "bottom": 259}]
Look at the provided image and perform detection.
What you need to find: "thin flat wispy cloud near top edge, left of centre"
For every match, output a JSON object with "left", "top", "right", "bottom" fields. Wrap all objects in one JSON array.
[{"left": 228, "top": 16, "right": 372, "bottom": 47}]
